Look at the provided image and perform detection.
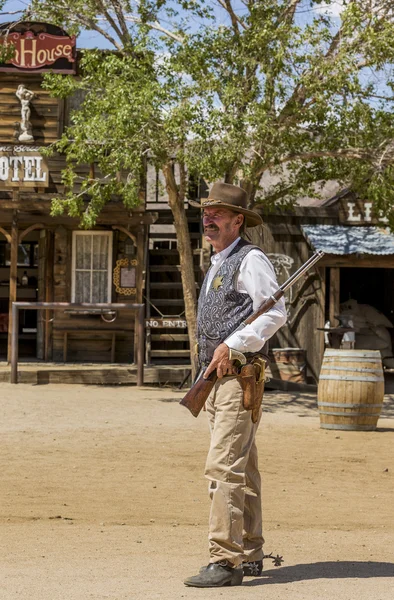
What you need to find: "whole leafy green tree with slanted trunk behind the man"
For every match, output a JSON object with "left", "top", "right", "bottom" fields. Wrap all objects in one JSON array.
[{"left": 3, "top": 0, "right": 394, "bottom": 372}]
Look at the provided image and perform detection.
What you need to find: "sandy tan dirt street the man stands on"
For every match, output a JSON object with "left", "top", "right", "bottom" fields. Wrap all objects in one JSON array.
[{"left": 0, "top": 384, "right": 394, "bottom": 600}]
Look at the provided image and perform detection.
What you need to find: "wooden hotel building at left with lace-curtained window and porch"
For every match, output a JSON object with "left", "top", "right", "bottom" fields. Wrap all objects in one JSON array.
[{"left": 0, "top": 23, "right": 157, "bottom": 363}]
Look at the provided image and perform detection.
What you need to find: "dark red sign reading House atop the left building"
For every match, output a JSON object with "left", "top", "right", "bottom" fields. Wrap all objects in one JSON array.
[{"left": 0, "top": 22, "right": 76, "bottom": 73}]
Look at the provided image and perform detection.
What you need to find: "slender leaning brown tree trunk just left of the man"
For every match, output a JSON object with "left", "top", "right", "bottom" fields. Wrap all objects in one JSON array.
[{"left": 162, "top": 163, "right": 197, "bottom": 379}]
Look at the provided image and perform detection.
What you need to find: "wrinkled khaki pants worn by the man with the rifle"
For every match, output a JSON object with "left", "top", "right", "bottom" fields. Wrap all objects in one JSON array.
[{"left": 205, "top": 377, "right": 264, "bottom": 566}]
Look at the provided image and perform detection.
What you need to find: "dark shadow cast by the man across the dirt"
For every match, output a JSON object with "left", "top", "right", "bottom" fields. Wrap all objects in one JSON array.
[{"left": 243, "top": 561, "right": 394, "bottom": 586}]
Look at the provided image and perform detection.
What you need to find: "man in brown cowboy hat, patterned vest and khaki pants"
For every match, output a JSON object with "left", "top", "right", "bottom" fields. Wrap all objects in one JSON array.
[{"left": 185, "top": 183, "right": 286, "bottom": 587}]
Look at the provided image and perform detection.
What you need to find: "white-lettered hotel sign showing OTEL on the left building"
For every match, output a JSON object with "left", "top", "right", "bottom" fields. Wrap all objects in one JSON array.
[{"left": 0, "top": 147, "right": 49, "bottom": 188}]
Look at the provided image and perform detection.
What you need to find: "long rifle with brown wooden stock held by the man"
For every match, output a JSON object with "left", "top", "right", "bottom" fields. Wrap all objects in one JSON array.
[{"left": 180, "top": 250, "right": 324, "bottom": 417}]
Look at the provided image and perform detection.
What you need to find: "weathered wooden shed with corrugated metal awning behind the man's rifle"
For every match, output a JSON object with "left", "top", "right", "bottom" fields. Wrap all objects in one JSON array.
[{"left": 250, "top": 195, "right": 394, "bottom": 383}]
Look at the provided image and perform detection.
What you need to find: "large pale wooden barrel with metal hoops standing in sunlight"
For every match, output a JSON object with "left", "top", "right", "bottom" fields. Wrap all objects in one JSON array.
[{"left": 317, "top": 348, "right": 384, "bottom": 431}]
